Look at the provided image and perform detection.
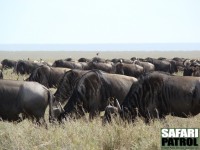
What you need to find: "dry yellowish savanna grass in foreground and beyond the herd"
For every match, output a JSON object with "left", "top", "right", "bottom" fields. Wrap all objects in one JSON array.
[{"left": 0, "top": 52, "right": 200, "bottom": 150}]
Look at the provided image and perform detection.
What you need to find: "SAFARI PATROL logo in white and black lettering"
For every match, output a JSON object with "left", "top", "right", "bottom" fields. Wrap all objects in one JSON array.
[{"left": 161, "top": 128, "right": 200, "bottom": 149}]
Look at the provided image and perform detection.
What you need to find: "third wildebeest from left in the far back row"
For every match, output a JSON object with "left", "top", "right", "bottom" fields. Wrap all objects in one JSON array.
[{"left": 52, "top": 59, "right": 83, "bottom": 69}]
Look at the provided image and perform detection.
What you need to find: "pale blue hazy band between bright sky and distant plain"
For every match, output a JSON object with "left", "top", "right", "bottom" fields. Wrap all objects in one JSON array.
[{"left": 0, "top": 43, "right": 200, "bottom": 51}]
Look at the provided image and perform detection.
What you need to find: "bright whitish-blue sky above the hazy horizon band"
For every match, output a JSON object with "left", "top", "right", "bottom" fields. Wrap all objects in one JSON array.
[{"left": 0, "top": 0, "right": 200, "bottom": 50}]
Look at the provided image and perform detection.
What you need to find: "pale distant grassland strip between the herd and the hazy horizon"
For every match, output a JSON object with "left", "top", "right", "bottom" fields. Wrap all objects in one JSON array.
[{"left": 0, "top": 50, "right": 200, "bottom": 60}]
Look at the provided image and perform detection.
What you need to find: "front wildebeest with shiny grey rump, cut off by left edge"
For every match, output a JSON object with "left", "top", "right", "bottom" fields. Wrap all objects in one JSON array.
[{"left": 0, "top": 80, "right": 52, "bottom": 123}]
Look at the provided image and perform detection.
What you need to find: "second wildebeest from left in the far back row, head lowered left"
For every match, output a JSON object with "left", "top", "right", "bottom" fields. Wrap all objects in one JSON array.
[{"left": 14, "top": 60, "right": 44, "bottom": 75}]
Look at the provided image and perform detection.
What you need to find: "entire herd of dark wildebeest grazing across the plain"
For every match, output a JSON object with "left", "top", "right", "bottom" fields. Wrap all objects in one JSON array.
[{"left": 0, "top": 57, "right": 200, "bottom": 124}]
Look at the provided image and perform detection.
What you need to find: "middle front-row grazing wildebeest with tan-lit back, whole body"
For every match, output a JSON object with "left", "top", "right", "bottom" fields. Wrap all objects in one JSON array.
[{"left": 50, "top": 70, "right": 137, "bottom": 121}]
